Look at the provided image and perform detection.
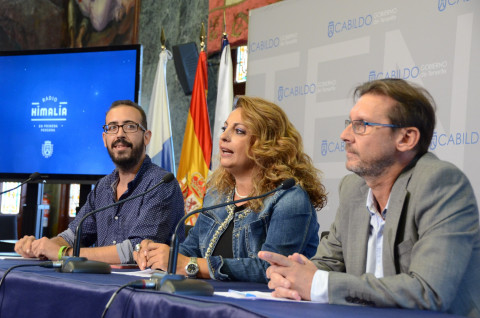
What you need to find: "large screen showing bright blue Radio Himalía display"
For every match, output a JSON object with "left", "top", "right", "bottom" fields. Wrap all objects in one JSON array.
[{"left": 0, "top": 45, "right": 142, "bottom": 183}]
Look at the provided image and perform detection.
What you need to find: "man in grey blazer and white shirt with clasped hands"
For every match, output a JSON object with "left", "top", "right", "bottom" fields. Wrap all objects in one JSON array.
[{"left": 259, "top": 79, "right": 480, "bottom": 317}]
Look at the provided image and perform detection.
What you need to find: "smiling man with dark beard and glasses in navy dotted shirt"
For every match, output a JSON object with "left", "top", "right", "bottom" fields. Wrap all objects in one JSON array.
[{"left": 15, "top": 100, "right": 184, "bottom": 264}]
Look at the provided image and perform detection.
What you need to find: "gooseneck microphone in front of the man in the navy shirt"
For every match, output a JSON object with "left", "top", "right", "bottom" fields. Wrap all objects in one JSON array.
[{"left": 60, "top": 173, "right": 175, "bottom": 274}]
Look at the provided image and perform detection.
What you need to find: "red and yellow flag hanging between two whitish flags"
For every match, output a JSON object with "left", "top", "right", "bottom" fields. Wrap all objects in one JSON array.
[{"left": 177, "top": 51, "right": 212, "bottom": 225}]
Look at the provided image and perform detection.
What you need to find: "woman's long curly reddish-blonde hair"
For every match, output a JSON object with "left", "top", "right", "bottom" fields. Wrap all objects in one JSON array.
[{"left": 207, "top": 96, "right": 327, "bottom": 212}]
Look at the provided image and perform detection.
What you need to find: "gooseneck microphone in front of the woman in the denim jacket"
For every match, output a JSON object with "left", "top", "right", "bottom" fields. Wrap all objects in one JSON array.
[{"left": 157, "top": 178, "right": 295, "bottom": 296}]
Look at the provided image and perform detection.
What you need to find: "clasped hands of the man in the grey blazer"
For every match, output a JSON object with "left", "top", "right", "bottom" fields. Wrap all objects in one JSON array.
[{"left": 258, "top": 251, "right": 317, "bottom": 300}]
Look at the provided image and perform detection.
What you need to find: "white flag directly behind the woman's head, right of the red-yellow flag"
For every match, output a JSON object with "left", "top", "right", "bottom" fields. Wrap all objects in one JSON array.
[{"left": 212, "top": 34, "right": 233, "bottom": 170}]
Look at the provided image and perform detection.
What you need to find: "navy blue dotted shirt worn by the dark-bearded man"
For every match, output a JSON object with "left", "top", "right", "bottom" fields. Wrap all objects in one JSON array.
[{"left": 59, "top": 156, "right": 185, "bottom": 263}]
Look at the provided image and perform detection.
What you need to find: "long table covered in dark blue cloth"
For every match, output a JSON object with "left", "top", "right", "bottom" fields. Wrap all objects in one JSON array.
[{"left": 0, "top": 260, "right": 462, "bottom": 318}]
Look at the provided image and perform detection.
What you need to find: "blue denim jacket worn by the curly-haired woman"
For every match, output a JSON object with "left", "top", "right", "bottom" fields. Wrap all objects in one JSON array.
[{"left": 179, "top": 185, "right": 319, "bottom": 283}]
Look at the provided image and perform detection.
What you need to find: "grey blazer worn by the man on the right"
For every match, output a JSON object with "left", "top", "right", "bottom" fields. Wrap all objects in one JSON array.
[{"left": 312, "top": 153, "right": 480, "bottom": 317}]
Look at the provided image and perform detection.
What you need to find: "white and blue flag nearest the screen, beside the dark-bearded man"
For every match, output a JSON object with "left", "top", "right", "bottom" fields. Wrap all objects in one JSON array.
[{"left": 147, "top": 50, "right": 175, "bottom": 174}]
